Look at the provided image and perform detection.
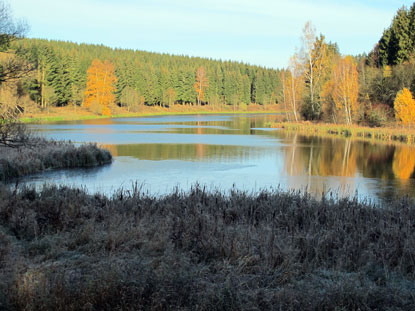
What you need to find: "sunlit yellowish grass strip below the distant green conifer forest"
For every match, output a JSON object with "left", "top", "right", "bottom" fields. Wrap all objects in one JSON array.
[{"left": 20, "top": 104, "right": 281, "bottom": 123}]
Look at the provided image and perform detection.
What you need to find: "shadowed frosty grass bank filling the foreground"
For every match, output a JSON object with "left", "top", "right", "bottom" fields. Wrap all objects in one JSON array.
[{"left": 0, "top": 187, "right": 415, "bottom": 310}]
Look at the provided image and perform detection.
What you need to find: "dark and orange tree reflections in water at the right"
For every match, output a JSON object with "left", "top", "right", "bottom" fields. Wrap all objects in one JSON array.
[{"left": 283, "top": 134, "right": 415, "bottom": 197}]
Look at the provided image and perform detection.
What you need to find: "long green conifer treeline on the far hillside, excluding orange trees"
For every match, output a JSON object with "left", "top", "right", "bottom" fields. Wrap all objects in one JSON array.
[{"left": 14, "top": 39, "right": 280, "bottom": 110}]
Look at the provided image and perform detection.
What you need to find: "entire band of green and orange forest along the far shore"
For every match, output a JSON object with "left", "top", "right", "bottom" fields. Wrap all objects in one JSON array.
[{"left": 0, "top": 4, "right": 415, "bottom": 126}]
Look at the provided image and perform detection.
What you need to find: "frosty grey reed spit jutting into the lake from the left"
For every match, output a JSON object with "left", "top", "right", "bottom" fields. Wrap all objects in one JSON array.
[{"left": 0, "top": 138, "right": 112, "bottom": 182}]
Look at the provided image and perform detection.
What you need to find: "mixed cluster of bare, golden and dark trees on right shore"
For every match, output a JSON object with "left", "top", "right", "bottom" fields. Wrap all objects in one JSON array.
[{"left": 278, "top": 3, "right": 415, "bottom": 126}]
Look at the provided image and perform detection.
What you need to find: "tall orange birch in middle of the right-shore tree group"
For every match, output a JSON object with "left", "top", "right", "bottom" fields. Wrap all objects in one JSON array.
[{"left": 323, "top": 56, "right": 359, "bottom": 124}]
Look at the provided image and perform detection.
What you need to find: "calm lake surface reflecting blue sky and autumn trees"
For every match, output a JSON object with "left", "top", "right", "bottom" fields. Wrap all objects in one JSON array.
[{"left": 23, "top": 115, "right": 415, "bottom": 200}]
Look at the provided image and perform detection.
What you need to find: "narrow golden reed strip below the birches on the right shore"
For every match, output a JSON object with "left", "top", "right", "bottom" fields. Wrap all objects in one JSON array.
[{"left": 270, "top": 122, "right": 415, "bottom": 144}]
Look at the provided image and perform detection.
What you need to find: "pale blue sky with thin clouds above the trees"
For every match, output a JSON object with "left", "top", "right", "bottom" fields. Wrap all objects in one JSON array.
[{"left": 9, "top": 0, "right": 413, "bottom": 68}]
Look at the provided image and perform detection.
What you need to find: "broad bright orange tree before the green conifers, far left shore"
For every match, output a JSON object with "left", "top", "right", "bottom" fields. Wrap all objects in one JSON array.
[{"left": 84, "top": 59, "right": 117, "bottom": 116}]
